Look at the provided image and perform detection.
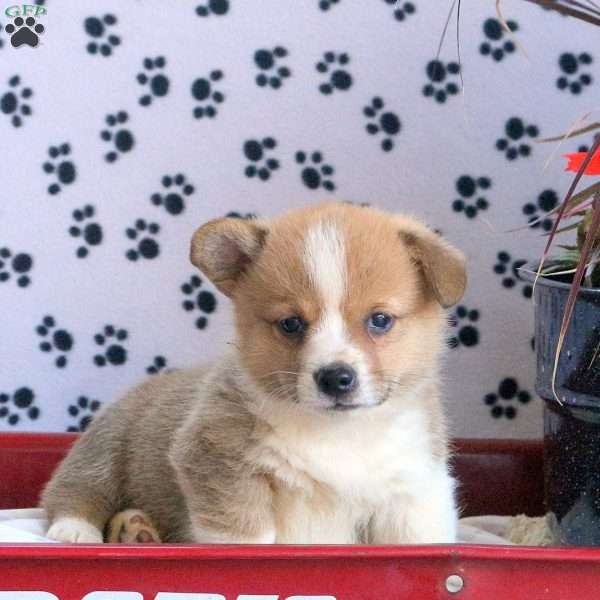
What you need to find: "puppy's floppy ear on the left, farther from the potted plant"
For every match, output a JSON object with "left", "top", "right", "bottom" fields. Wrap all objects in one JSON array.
[{"left": 190, "top": 218, "right": 268, "bottom": 297}]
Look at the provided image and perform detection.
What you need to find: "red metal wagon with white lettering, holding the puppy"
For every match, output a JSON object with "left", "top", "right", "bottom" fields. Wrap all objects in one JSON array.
[{"left": 0, "top": 434, "right": 600, "bottom": 600}]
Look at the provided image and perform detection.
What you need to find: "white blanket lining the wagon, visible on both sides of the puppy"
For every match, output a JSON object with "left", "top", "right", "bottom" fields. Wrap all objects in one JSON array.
[{"left": 0, "top": 508, "right": 513, "bottom": 544}]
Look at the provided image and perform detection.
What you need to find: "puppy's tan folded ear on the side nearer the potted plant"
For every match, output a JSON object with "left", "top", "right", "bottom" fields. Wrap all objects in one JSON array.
[{"left": 400, "top": 221, "right": 467, "bottom": 308}]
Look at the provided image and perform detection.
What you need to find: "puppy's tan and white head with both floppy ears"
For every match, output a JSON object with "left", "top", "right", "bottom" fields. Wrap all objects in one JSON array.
[{"left": 191, "top": 203, "right": 466, "bottom": 414}]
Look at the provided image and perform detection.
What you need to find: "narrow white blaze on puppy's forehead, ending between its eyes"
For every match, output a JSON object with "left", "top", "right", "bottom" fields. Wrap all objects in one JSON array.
[{"left": 304, "top": 221, "right": 346, "bottom": 313}]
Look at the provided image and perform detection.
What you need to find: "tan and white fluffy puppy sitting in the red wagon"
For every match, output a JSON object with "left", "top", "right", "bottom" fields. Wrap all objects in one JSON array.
[{"left": 42, "top": 203, "right": 466, "bottom": 544}]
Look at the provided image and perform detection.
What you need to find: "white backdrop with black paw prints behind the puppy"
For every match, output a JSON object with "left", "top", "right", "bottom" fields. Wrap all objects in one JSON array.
[{"left": 0, "top": 0, "right": 600, "bottom": 437}]
